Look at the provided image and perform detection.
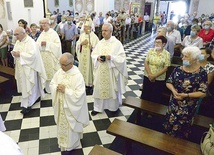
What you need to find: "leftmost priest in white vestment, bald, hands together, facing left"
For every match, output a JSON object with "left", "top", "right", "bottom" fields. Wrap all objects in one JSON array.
[{"left": 11, "top": 27, "right": 47, "bottom": 114}]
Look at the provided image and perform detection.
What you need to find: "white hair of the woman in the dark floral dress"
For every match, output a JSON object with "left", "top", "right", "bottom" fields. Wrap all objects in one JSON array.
[{"left": 182, "top": 46, "right": 201, "bottom": 60}]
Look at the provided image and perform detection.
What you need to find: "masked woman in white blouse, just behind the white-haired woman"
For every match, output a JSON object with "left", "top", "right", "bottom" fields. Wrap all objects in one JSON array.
[{"left": 181, "top": 25, "right": 203, "bottom": 48}]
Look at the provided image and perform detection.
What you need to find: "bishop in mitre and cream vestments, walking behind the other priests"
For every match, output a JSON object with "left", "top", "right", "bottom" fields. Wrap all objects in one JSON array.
[{"left": 76, "top": 19, "right": 99, "bottom": 95}]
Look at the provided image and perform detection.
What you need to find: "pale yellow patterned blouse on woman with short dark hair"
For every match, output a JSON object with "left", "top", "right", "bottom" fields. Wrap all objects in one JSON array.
[{"left": 144, "top": 48, "right": 170, "bottom": 81}]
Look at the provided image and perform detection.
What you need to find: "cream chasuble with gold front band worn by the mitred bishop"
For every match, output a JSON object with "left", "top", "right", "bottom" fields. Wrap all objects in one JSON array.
[{"left": 76, "top": 32, "right": 99, "bottom": 86}]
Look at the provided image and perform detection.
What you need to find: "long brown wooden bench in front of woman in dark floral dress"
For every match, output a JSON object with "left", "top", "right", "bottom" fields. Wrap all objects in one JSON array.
[{"left": 106, "top": 119, "right": 201, "bottom": 155}]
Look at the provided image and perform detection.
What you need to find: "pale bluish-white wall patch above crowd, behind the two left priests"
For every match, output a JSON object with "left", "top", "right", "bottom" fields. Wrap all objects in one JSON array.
[{"left": 47, "top": 0, "right": 74, "bottom": 13}]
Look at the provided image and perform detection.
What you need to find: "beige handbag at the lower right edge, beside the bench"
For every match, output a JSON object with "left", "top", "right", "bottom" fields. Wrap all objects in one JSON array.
[{"left": 200, "top": 124, "right": 214, "bottom": 155}]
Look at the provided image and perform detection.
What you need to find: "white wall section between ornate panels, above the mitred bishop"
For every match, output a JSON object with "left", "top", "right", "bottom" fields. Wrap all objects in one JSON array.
[{"left": 94, "top": 0, "right": 114, "bottom": 17}]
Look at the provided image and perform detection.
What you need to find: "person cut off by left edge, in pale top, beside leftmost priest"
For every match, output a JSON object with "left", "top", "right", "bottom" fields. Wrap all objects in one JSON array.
[{"left": 0, "top": 24, "right": 8, "bottom": 66}]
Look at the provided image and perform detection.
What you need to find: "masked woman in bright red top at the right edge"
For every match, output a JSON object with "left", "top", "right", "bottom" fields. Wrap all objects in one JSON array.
[{"left": 198, "top": 20, "right": 214, "bottom": 46}]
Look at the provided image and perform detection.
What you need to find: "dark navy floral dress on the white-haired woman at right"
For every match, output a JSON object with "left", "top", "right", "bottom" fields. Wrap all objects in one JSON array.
[{"left": 163, "top": 67, "right": 207, "bottom": 138}]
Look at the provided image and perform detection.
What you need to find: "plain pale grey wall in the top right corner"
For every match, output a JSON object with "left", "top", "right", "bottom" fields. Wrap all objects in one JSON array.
[{"left": 198, "top": 0, "right": 214, "bottom": 16}]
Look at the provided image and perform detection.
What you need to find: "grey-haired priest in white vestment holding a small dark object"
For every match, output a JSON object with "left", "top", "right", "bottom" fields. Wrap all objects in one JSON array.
[{"left": 91, "top": 23, "right": 128, "bottom": 116}]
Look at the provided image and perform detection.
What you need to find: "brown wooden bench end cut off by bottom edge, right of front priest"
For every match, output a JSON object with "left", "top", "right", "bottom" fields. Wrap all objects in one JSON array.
[{"left": 88, "top": 145, "right": 122, "bottom": 155}]
